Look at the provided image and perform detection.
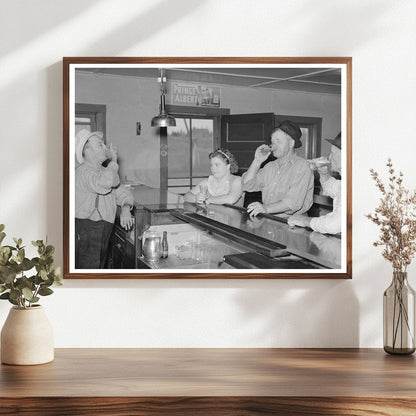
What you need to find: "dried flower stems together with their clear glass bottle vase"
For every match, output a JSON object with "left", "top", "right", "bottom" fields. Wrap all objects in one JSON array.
[{"left": 367, "top": 159, "right": 416, "bottom": 354}]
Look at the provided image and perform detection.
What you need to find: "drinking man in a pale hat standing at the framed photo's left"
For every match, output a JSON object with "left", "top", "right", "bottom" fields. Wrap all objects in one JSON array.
[{"left": 75, "top": 129, "right": 134, "bottom": 269}]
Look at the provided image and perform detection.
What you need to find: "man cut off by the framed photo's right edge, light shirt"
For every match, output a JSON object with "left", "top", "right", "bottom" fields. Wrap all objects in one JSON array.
[{"left": 288, "top": 133, "right": 341, "bottom": 234}]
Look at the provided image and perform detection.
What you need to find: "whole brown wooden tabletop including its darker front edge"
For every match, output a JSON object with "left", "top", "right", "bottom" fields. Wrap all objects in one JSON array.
[{"left": 0, "top": 349, "right": 416, "bottom": 416}]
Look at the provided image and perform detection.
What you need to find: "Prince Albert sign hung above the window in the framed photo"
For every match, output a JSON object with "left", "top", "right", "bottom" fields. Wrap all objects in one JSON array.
[{"left": 169, "top": 82, "right": 221, "bottom": 107}]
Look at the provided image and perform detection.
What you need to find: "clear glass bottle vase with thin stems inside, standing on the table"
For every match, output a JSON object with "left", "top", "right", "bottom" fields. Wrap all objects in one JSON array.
[{"left": 383, "top": 271, "right": 415, "bottom": 354}]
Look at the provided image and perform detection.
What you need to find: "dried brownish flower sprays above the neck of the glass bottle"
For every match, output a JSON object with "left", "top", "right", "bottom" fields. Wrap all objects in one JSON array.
[{"left": 366, "top": 159, "right": 416, "bottom": 272}]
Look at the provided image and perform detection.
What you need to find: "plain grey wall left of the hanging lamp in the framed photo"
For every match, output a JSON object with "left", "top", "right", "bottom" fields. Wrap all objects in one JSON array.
[{"left": 75, "top": 73, "right": 160, "bottom": 187}]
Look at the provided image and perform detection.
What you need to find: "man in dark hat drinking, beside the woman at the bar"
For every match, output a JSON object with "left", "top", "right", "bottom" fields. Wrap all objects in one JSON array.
[{"left": 242, "top": 120, "right": 314, "bottom": 216}]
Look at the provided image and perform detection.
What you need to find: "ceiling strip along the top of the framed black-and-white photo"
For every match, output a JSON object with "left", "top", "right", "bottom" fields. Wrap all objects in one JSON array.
[{"left": 77, "top": 66, "right": 341, "bottom": 94}]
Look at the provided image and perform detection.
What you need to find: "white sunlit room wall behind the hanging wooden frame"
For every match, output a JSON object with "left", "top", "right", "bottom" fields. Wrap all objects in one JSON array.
[{"left": 0, "top": 0, "right": 416, "bottom": 347}]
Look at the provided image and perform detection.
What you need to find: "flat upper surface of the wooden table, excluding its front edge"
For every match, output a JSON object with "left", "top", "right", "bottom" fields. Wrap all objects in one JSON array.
[{"left": 0, "top": 349, "right": 416, "bottom": 399}]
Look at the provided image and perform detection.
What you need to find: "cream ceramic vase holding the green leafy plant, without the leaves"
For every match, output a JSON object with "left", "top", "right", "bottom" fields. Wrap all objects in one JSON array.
[{"left": 1, "top": 305, "right": 54, "bottom": 365}]
